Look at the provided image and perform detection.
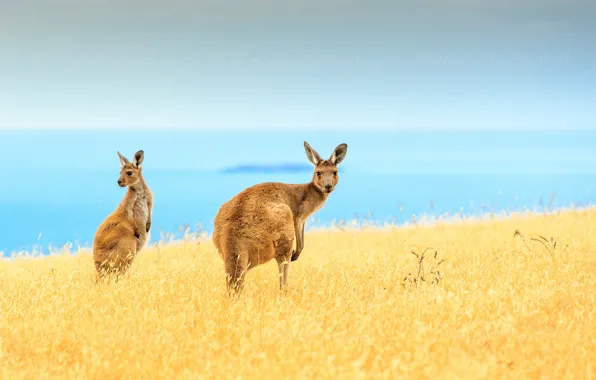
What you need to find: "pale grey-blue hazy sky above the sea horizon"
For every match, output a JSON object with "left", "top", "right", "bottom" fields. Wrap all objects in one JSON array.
[{"left": 0, "top": 0, "right": 596, "bottom": 130}]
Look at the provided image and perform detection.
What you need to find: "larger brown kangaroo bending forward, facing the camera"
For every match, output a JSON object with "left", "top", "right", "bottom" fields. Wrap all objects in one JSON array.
[{"left": 213, "top": 141, "right": 348, "bottom": 295}]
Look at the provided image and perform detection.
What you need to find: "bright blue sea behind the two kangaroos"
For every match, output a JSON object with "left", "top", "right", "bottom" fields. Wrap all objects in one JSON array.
[{"left": 0, "top": 130, "right": 596, "bottom": 255}]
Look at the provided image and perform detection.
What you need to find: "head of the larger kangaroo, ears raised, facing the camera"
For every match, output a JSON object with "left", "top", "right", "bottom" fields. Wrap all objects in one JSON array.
[{"left": 304, "top": 141, "right": 348, "bottom": 194}]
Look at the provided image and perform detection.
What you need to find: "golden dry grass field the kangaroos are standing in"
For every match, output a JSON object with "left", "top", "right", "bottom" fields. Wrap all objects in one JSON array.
[{"left": 0, "top": 210, "right": 596, "bottom": 379}]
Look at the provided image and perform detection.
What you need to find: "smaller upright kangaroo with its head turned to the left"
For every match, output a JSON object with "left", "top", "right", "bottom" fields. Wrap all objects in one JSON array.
[{"left": 93, "top": 150, "right": 153, "bottom": 280}]
